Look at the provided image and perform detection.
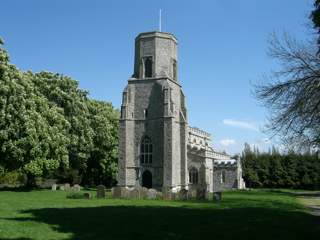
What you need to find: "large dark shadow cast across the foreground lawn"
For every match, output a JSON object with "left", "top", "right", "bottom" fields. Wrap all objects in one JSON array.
[{"left": 6, "top": 202, "right": 320, "bottom": 240}]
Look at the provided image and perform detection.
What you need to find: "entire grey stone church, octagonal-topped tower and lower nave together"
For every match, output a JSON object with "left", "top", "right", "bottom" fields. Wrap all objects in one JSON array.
[{"left": 118, "top": 31, "right": 244, "bottom": 192}]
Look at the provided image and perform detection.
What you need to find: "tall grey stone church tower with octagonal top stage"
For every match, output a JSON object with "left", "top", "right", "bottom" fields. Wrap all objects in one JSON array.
[{"left": 118, "top": 32, "right": 188, "bottom": 191}]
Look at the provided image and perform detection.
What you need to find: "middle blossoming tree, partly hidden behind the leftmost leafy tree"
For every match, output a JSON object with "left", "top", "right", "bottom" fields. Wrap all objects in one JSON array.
[{"left": 34, "top": 72, "right": 94, "bottom": 174}]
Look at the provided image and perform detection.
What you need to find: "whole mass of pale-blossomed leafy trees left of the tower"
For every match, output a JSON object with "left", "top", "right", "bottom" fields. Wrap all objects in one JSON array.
[{"left": 0, "top": 40, "right": 119, "bottom": 188}]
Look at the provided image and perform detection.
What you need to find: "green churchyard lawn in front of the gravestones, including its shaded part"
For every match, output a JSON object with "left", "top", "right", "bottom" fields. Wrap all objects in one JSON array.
[{"left": 0, "top": 190, "right": 320, "bottom": 240}]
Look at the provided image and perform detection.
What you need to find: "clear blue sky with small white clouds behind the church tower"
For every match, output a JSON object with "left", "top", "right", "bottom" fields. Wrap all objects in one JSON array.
[{"left": 0, "top": 0, "right": 312, "bottom": 153}]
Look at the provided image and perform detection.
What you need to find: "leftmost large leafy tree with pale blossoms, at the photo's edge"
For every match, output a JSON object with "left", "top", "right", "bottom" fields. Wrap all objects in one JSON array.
[{"left": 0, "top": 39, "right": 69, "bottom": 182}]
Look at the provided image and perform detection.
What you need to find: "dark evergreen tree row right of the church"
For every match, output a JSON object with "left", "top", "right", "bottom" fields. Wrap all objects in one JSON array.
[{"left": 241, "top": 144, "right": 320, "bottom": 189}]
